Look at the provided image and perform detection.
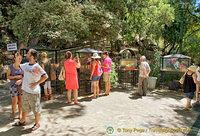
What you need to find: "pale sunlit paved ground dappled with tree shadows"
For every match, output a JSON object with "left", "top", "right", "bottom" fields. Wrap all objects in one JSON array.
[{"left": 0, "top": 81, "right": 200, "bottom": 136}]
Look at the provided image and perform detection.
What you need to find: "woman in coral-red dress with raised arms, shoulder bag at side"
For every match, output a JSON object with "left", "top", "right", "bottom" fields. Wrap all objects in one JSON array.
[{"left": 64, "top": 51, "right": 80, "bottom": 104}]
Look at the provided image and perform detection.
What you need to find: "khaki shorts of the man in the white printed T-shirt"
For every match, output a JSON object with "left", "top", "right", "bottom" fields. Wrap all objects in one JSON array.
[{"left": 22, "top": 91, "right": 41, "bottom": 115}]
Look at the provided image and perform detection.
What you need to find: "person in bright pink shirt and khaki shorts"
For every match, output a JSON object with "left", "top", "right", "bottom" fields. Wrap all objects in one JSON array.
[{"left": 102, "top": 51, "right": 112, "bottom": 95}]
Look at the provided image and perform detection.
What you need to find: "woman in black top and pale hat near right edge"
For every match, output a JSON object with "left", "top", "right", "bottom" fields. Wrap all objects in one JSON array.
[{"left": 183, "top": 66, "right": 198, "bottom": 110}]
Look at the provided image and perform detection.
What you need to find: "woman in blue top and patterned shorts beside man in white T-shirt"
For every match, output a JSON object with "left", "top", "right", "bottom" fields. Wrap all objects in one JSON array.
[{"left": 7, "top": 53, "right": 23, "bottom": 120}]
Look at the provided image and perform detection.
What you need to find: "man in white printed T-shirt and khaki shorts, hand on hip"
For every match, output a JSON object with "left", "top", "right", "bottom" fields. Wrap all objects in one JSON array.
[{"left": 14, "top": 49, "right": 48, "bottom": 130}]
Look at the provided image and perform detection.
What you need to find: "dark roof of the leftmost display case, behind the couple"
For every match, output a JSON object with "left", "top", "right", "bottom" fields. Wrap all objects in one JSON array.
[{"left": 21, "top": 45, "right": 60, "bottom": 51}]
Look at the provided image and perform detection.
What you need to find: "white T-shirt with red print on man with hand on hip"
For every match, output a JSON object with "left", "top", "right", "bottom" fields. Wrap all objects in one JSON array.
[{"left": 20, "top": 63, "right": 46, "bottom": 94}]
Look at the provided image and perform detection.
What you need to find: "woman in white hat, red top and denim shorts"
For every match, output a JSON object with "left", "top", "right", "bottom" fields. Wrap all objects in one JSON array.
[{"left": 90, "top": 53, "right": 103, "bottom": 98}]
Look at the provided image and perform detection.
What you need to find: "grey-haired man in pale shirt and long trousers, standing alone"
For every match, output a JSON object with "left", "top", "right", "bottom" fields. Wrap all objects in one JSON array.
[{"left": 138, "top": 56, "right": 151, "bottom": 96}]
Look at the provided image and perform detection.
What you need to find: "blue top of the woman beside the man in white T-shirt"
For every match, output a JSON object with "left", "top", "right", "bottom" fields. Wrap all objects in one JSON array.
[{"left": 8, "top": 64, "right": 23, "bottom": 87}]
